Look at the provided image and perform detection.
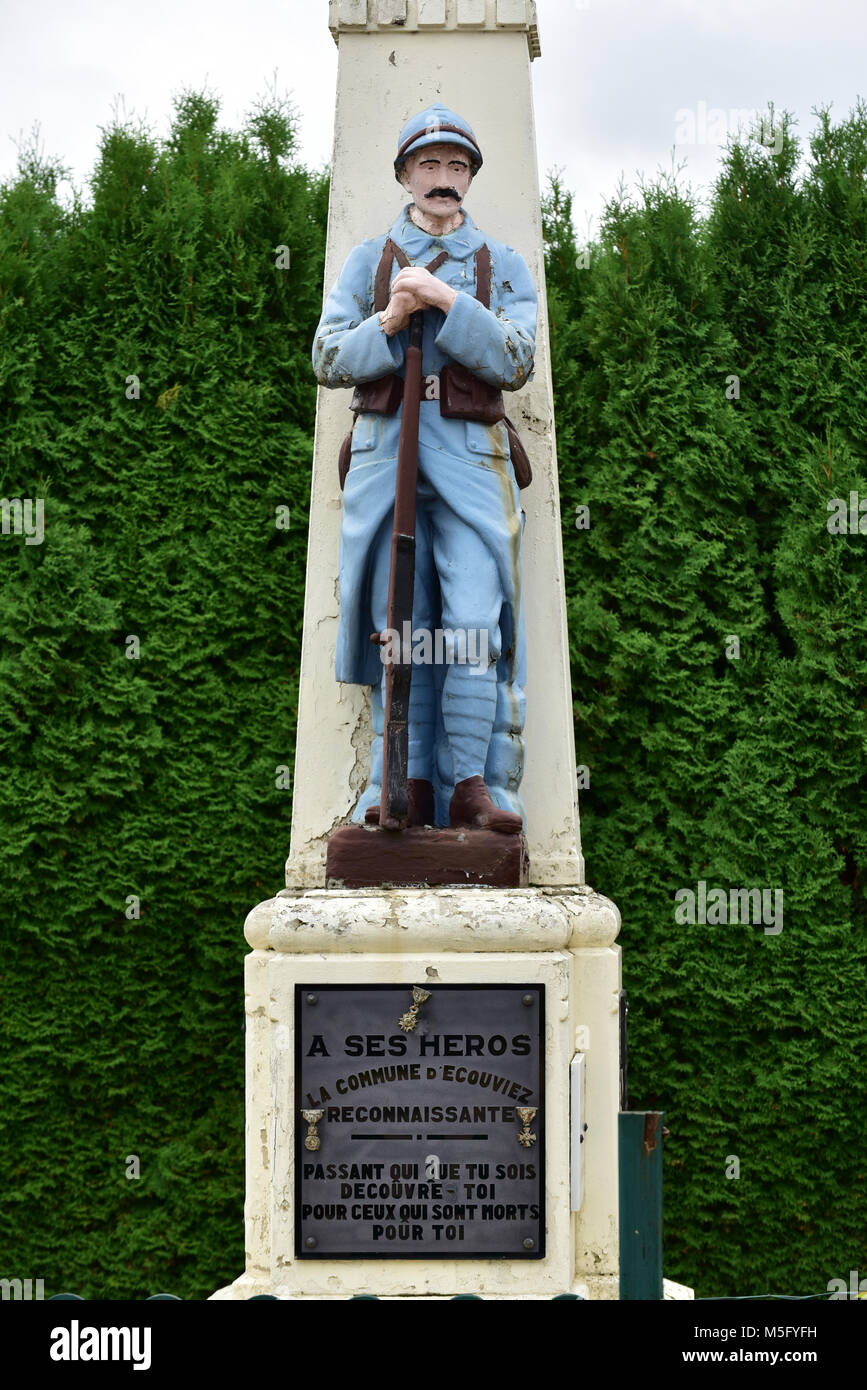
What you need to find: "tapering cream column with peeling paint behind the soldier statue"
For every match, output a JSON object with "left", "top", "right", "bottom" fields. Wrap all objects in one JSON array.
[{"left": 286, "top": 0, "right": 584, "bottom": 888}]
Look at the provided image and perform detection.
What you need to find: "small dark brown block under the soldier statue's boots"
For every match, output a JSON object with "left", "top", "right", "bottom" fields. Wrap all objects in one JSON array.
[{"left": 325, "top": 826, "right": 529, "bottom": 888}]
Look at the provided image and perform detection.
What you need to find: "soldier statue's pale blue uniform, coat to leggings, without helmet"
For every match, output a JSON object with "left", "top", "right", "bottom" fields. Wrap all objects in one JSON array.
[{"left": 313, "top": 116, "right": 536, "bottom": 824}]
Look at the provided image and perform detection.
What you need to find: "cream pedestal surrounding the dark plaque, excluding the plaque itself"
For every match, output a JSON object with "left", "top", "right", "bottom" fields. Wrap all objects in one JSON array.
[{"left": 215, "top": 888, "right": 620, "bottom": 1298}]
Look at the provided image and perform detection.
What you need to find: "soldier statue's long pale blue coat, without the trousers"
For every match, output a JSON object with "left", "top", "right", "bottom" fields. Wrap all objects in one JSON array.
[{"left": 313, "top": 206, "right": 536, "bottom": 805}]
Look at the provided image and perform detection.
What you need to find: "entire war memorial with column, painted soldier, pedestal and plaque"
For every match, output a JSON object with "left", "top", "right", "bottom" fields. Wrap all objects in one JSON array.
[{"left": 214, "top": 0, "right": 636, "bottom": 1300}]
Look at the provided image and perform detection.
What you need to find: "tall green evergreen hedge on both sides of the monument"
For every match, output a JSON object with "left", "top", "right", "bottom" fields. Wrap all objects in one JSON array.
[{"left": 0, "top": 92, "right": 867, "bottom": 1298}]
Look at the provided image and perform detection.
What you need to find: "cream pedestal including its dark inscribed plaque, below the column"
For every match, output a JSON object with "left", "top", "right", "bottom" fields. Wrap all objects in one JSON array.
[{"left": 214, "top": 884, "right": 620, "bottom": 1300}]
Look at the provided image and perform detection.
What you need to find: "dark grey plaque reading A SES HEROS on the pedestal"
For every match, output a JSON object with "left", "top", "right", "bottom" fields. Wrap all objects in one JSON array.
[{"left": 295, "top": 983, "right": 545, "bottom": 1259}]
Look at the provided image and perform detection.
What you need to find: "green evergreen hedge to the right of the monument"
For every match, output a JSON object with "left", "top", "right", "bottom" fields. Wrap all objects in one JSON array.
[{"left": 545, "top": 107, "right": 867, "bottom": 1297}]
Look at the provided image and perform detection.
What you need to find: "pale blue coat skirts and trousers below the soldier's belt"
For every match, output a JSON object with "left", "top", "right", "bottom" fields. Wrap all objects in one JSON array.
[{"left": 338, "top": 442, "right": 527, "bottom": 824}]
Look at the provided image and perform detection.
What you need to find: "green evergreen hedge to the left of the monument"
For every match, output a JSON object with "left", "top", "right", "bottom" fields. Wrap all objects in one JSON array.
[{"left": 0, "top": 93, "right": 328, "bottom": 1298}]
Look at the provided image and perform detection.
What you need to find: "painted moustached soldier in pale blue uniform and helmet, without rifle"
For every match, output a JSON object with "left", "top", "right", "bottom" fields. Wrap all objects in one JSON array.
[{"left": 313, "top": 104, "right": 536, "bottom": 834}]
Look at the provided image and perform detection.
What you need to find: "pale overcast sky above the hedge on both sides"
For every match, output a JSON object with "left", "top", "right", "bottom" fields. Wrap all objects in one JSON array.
[{"left": 0, "top": 0, "right": 867, "bottom": 234}]
